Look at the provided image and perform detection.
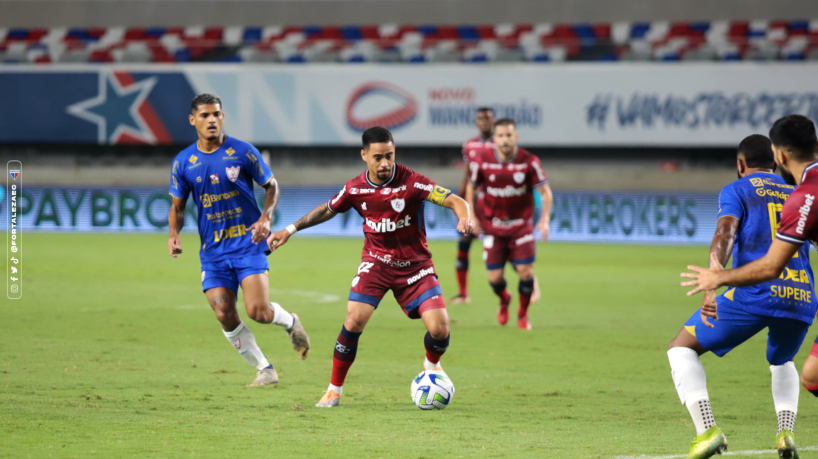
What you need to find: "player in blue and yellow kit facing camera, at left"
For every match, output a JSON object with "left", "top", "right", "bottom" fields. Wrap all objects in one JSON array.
[{"left": 168, "top": 94, "right": 310, "bottom": 386}]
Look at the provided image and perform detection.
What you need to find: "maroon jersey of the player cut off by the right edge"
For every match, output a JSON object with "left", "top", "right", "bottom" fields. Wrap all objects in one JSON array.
[{"left": 775, "top": 161, "right": 818, "bottom": 245}]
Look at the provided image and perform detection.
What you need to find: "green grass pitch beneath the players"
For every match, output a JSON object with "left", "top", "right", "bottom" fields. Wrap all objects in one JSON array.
[{"left": 0, "top": 234, "right": 818, "bottom": 459}]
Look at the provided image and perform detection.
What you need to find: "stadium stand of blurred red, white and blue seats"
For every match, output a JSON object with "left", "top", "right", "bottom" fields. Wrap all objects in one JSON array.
[{"left": 0, "top": 20, "right": 818, "bottom": 64}]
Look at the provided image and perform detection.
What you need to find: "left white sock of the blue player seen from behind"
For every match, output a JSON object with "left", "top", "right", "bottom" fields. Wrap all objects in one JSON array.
[{"left": 667, "top": 347, "right": 716, "bottom": 435}]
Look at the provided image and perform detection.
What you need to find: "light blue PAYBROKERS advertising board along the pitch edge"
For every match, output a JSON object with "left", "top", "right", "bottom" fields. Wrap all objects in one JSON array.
[{"left": 0, "top": 187, "right": 718, "bottom": 244}]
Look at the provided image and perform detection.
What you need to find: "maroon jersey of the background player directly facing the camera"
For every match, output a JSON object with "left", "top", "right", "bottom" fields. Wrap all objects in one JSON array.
[{"left": 469, "top": 148, "right": 548, "bottom": 236}]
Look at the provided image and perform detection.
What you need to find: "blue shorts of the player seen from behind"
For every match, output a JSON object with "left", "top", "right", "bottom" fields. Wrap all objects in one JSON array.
[{"left": 685, "top": 302, "right": 809, "bottom": 365}]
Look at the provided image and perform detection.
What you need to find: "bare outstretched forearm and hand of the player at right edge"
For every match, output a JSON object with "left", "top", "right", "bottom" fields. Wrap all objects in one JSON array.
[{"left": 681, "top": 239, "right": 800, "bottom": 296}]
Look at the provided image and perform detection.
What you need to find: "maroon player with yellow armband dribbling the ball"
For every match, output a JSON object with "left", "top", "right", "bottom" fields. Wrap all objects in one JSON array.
[{"left": 267, "top": 126, "right": 472, "bottom": 408}]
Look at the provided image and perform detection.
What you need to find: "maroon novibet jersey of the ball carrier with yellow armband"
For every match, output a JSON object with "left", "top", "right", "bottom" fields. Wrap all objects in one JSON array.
[{"left": 327, "top": 164, "right": 451, "bottom": 268}]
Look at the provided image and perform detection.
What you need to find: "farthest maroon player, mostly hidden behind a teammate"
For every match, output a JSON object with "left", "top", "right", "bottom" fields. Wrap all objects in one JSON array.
[{"left": 449, "top": 107, "right": 542, "bottom": 304}]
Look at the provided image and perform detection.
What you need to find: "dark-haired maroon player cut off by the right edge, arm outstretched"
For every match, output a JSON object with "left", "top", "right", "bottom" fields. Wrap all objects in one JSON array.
[{"left": 681, "top": 115, "right": 818, "bottom": 410}]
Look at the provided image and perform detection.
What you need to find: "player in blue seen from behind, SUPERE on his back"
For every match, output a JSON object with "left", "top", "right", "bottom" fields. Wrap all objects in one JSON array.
[{"left": 667, "top": 135, "right": 816, "bottom": 458}]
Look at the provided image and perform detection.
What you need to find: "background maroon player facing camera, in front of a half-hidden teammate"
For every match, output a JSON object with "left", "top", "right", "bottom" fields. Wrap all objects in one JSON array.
[{"left": 466, "top": 118, "right": 553, "bottom": 330}]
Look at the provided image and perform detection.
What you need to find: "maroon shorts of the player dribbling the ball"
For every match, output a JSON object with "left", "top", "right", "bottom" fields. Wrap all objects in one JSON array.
[{"left": 349, "top": 255, "right": 446, "bottom": 319}]
